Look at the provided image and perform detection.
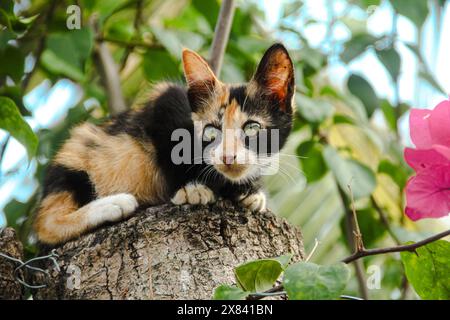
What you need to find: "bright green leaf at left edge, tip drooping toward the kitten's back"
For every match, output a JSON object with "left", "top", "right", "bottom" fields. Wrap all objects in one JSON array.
[{"left": 0, "top": 97, "right": 38, "bottom": 159}]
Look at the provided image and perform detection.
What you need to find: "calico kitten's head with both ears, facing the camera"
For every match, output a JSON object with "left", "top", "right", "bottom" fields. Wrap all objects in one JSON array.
[{"left": 183, "top": 44, "right": 295, "bottom": 183}]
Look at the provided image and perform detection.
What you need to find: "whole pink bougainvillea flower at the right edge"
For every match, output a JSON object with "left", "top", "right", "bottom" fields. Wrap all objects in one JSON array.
[{"left": 405, "top": 100, "right": 450, "bottom": 221}]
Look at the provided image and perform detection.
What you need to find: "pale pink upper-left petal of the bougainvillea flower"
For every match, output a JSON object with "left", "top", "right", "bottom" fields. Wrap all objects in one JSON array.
[{"left": 409, "top": 109, "right": 433, "bottom": 149}]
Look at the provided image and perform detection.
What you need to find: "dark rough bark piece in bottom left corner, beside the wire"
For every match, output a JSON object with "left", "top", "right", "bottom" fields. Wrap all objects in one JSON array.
[{"left": 0, "top": 228, "right": 24, "bottom": 300}]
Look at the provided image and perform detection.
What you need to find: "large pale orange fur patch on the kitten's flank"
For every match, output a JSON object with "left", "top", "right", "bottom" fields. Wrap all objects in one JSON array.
[{"left": 55, "top": 123, "right": 167, "bottom": 204}]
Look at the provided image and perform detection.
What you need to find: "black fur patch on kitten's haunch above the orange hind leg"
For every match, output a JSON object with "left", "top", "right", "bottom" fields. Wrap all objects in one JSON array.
[{"left": 43, "top": 164, "right": 96, "bottom": 207}]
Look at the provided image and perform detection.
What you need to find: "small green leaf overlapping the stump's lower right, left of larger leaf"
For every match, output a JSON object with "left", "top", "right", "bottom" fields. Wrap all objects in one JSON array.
[{"left": 234, "top": 256, "right": 291, "bottom": 292}]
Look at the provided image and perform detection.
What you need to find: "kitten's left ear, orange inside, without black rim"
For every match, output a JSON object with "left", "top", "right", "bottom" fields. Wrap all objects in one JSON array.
[{"left": 183, "top": 49, "right": 219, "bottom": 87}]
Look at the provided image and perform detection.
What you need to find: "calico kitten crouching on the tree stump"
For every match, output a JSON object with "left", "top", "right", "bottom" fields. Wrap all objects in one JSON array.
[{"left": 34, "top": 44, "right": 295, "bottom": 244}]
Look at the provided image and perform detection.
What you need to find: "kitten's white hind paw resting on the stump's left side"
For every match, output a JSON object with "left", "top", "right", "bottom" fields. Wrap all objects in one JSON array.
[{"left": 87, "top": 193, "right": 138, "bottom": 226}]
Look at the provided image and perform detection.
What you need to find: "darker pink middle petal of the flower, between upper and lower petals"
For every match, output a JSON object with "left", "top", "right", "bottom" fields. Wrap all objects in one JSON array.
[{"left": 404, "top": 146, "right": 450, "bottom": 172}]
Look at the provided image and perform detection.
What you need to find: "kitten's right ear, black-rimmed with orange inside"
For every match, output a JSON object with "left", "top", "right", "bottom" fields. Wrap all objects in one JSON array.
[{"left": 250, "top": 43, "right": 295, "bottom": 109}]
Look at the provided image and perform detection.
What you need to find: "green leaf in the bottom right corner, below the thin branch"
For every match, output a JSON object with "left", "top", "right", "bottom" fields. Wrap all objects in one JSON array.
[{"left": 400, "top": 240, "right": 450, "bottom": 300}]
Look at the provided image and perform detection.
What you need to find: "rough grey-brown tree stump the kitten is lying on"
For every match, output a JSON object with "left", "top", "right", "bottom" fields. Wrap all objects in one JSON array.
[{"left": 34, "top": 203, "right": 303, "bottom": 299}]
